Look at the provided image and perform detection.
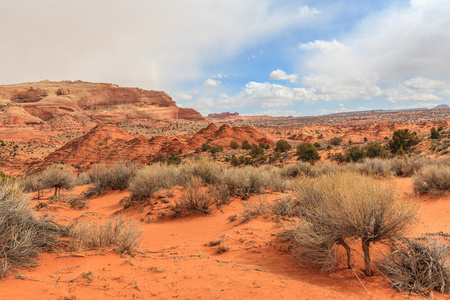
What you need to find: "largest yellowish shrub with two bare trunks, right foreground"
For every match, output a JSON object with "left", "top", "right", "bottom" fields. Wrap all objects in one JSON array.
[{"left": 290, "top": 173, "right": 416, "bottom": 276}]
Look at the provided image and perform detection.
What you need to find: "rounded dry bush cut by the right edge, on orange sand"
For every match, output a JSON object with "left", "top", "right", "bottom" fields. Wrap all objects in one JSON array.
[{"left": 413, "top": 165, "right": 450, "bottom": 194}]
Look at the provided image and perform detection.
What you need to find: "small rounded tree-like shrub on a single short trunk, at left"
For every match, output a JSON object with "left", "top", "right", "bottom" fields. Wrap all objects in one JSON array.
[{"left": 40, "top": 164, "right": 77, "bottom": 198}]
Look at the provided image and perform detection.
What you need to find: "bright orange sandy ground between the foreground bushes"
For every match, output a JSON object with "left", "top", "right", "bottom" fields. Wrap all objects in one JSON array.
[{"left": 0, "top": 178, "right": 450, "bottom": 300}]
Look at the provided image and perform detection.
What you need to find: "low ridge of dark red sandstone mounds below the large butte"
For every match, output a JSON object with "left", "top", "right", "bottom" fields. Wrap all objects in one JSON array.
[{"left": 28, "top": 123, "right": 275, "bottom": 173}]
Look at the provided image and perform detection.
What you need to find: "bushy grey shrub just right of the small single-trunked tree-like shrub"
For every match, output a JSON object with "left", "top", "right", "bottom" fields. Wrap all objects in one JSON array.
[{"left": 87, "top": 162, "right": 138, "bottom": 195}]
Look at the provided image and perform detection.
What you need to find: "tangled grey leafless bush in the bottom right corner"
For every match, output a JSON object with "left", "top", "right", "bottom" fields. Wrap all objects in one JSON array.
[{"left": 378, "top": 237, "right": 450, "bottom": 297}]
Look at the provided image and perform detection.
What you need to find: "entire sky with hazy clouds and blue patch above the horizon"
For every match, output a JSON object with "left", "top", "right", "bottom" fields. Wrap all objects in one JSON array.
[{"left": 0, "top": 0, "right": 450, "bottom": 116}]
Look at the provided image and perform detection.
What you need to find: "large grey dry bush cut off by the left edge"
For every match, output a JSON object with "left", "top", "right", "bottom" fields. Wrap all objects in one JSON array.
[{"left": 0, "top": 181, "right": 63, "bottom": 277}]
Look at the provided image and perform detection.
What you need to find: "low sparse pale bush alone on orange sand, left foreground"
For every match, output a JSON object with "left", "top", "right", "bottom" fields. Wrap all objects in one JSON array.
[{"left": 69, "top": 215, "right": 142, "bottom": 255}]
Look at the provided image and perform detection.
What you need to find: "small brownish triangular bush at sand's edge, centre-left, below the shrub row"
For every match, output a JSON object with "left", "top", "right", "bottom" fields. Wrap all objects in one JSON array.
[{"left": 172, "top": 176, "right": 216, "bottom": 217}]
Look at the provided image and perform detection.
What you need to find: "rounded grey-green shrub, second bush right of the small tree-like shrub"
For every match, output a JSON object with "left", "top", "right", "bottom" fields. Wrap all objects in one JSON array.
[{"left": 128, "top": 164, "right": 180, "bottom": 199}]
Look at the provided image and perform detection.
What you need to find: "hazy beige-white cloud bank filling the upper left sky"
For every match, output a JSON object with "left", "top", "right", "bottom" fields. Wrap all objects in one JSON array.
[{"left": 0, "top": 0, "right": 305, "bottom": 90}]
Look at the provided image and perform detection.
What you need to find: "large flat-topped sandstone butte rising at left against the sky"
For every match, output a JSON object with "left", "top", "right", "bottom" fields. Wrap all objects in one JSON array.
[{"left": 0, "top": 81, "right": 206, "bottom": 126}]
